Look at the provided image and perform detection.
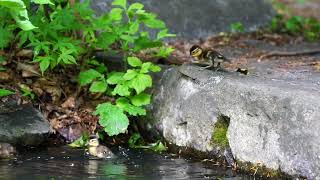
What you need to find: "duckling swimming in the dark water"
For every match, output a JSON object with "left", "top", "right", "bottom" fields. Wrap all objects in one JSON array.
[{"left": 88, "top": 135, "right": 115, "bottom": 158}]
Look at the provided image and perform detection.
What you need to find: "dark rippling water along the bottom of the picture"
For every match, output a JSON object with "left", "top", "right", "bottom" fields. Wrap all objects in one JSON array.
[{"left": 0, "top": 147, "right": 253, "bottom": 180}]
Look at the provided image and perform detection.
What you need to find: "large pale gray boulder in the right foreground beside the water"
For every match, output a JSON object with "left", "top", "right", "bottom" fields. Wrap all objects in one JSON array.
[{"left": 147, "top": 66, "right": 320, "bottom": 179}]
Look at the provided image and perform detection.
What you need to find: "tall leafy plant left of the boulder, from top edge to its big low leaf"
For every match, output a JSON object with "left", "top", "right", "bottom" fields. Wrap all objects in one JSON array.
[{"left": 79, "top": 0, "right": 174, "bottom": 136}]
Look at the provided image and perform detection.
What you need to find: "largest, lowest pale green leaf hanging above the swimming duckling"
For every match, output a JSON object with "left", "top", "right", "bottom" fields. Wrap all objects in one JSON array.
[{"left": 94, "top": 103, "right": 129, "bottom": 136}]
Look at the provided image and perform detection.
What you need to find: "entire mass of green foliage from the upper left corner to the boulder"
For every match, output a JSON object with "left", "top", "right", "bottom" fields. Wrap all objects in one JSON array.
[{"left": 0, "top": 0, "right": 175, "bottom": 142}]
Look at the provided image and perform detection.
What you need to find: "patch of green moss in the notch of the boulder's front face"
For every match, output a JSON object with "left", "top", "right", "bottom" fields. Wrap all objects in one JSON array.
[{"left": 211, "top": 115, "right": 230, "bottom": 147}]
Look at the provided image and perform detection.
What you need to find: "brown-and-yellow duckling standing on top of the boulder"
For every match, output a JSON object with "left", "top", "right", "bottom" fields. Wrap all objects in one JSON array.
[{"left": 190, "top": 45, "right": 231, "bottom": 71}]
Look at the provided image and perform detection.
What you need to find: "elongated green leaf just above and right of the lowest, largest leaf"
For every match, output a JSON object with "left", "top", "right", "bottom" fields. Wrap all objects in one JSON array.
[{"left": 116, "top": 97, "right": 147, "bottom": 116}]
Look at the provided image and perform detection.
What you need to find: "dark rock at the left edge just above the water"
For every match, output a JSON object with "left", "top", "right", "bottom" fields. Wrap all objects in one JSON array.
[{"left": 0, "top": 99, "right": 51, "bottom": 146}]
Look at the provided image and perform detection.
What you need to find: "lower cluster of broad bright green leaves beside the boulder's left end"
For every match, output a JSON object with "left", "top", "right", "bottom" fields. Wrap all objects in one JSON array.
[{"left": 84, "top": 56, "right": 161, "bottom": 136}]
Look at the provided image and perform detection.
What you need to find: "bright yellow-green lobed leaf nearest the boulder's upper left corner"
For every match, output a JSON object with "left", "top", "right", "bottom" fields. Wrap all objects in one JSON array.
[{"left": 130, "top": 74, "right": 152, "bottom": 94}]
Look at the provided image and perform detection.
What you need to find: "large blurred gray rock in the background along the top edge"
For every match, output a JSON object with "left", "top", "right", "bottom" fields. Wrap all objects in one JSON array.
[{"left": 91, "top": 0, "right": 274, "bottom": 39}]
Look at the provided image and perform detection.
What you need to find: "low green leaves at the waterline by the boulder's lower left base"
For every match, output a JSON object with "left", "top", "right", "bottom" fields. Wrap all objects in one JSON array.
[{"left": 128, "top": 133, "right": 167, "bottom": 153}]
